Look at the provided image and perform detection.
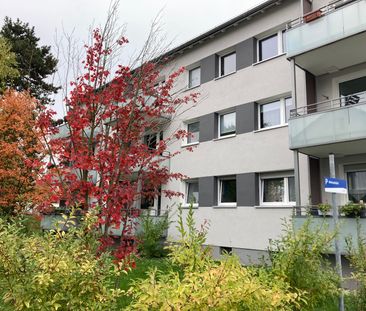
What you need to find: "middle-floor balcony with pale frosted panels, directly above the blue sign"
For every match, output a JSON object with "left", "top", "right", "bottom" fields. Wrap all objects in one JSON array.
[{"left": 288, "top": 92, "right": 366, "bottom": 158}]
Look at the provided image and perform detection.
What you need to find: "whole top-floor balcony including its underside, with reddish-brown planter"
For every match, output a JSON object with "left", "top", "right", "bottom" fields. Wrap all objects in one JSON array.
[{"left": 286, "top": 0, "right": 366, "bottom": 76}]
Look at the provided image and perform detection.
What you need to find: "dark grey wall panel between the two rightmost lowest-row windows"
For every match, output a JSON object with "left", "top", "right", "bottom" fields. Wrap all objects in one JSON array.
[{"left": 236, "top": 173, "right": 259, "bottom": 206}]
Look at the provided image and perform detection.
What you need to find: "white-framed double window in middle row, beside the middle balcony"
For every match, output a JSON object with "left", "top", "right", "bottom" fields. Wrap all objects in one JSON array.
[{"left": 259, "top": 97, "right": 293, "bottom": 129}]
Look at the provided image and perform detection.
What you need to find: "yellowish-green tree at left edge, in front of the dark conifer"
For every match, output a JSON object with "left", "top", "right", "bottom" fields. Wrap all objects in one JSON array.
[{"left": 0, "top": 37, "right": 19, "bottom": 92}]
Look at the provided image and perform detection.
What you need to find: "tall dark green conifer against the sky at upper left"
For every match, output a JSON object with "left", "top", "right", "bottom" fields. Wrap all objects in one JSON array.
[{"left": 0, "top": 17, "right": 59, "bottom": 103}]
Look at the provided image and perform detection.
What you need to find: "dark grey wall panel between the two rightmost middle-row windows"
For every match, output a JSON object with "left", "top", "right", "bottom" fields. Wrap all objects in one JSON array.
[{"left": 235, "top": 103, "right": 258, "bottom": 134}]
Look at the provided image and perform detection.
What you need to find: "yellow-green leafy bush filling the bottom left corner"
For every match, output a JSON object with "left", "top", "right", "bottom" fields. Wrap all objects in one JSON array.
[{"left": 0, "top": 214, "right": 121, "bottom": 310}]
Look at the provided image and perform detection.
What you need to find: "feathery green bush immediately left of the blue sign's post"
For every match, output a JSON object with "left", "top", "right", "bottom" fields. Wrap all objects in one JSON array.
[{"left": 269, "top": 218, "right": 339, "bottom": 310}]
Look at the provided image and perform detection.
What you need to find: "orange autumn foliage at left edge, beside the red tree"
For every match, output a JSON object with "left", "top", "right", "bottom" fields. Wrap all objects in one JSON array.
[{"left": 0, "top": 91, "right": 42, "bottom": 214}]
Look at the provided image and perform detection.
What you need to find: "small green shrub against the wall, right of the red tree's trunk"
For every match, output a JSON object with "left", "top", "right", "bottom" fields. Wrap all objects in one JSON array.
[{"left": 138, "top": 213, "right": 170, "bottom": 258}]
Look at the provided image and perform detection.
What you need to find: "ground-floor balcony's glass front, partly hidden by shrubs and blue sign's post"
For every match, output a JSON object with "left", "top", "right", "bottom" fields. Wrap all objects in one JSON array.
[{"left": 292, "top": 206, "right": 366, "bottom": 255}]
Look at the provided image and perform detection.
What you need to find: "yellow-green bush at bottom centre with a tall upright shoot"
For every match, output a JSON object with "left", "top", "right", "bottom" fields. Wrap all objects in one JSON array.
[{"left": 129, "top": 210, "right": 301, "bottom": 310}]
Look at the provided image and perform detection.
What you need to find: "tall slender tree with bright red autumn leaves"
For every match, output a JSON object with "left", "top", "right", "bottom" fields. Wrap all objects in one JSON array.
[{"left": 39, "top": 30, "right": 197, "bottom": 258}]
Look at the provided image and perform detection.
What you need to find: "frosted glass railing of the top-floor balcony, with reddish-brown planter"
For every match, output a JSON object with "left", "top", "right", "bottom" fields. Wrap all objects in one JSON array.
[{"left": 286, "top": 0, "right": 366, "bottom": 57}]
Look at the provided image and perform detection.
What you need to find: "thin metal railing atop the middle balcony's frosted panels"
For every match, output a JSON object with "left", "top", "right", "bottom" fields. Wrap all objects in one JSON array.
[{"left": 290, "top": 92, "right": 366, "bottom": 119}]
